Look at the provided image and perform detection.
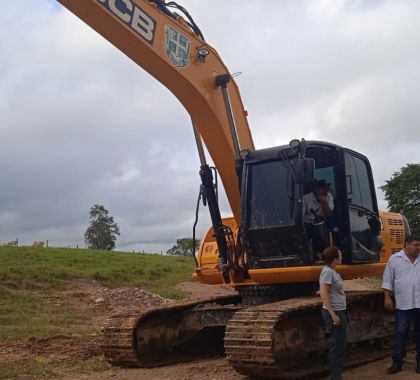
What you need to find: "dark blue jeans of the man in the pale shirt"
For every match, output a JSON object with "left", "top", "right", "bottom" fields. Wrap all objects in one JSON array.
[{"left": 392, "top": 309, "right": 420, "bottom": 366}]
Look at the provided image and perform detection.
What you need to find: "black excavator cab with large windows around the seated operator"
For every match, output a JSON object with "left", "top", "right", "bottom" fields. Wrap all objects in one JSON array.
[{"left": 241, "top": 142, "right": 383, "bottom": 269}]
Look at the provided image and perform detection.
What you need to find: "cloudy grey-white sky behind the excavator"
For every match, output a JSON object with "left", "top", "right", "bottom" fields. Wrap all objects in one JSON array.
[{"left": 0, "top": 0, "right": 420, "bottom": 252}]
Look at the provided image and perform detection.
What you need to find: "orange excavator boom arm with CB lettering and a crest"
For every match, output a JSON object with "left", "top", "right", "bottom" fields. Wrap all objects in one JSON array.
[{"left": 57, "top": 0, "right": 254, "bottom": 223}]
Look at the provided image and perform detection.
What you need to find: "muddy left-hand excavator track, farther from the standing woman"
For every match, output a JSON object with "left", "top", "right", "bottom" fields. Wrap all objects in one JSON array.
[{"left": 103, "top": 295, "right": 242, "bottom": 367}]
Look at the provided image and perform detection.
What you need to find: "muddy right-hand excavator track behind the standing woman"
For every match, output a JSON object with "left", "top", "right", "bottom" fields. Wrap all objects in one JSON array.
[{"left": 224, "top": 291, "right": 393, "bottom": 379}]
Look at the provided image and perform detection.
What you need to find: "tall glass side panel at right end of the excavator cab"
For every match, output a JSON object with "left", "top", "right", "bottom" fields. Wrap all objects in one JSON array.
[{"left": 344, "top": 151, "right": 383, "bottom": 263}]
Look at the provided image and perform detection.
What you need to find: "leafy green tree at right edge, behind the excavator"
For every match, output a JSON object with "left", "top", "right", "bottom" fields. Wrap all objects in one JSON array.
[{"left": 379, "top": 164, "right": 420, "bottom": 236}]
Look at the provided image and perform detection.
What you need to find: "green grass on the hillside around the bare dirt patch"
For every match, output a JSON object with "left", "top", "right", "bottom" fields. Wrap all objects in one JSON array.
[{"left": 0, "top": 247, "right": 194, "bottom": 341}]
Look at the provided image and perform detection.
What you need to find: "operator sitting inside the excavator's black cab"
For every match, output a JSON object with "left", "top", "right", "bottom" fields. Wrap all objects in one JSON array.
[{"left": 303, "top": 180, "right": 334, "bottom": 261}]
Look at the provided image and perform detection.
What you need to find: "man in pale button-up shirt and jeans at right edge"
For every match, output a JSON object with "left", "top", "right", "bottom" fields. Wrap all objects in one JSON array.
[{"left": 382, "top": 235, "right": 420, "bottom": 375}]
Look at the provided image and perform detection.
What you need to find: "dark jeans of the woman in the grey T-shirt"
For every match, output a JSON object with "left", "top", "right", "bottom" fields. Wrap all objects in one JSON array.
[{"left": 322, "top": 308, "right": 348, "bottom": 380}]
